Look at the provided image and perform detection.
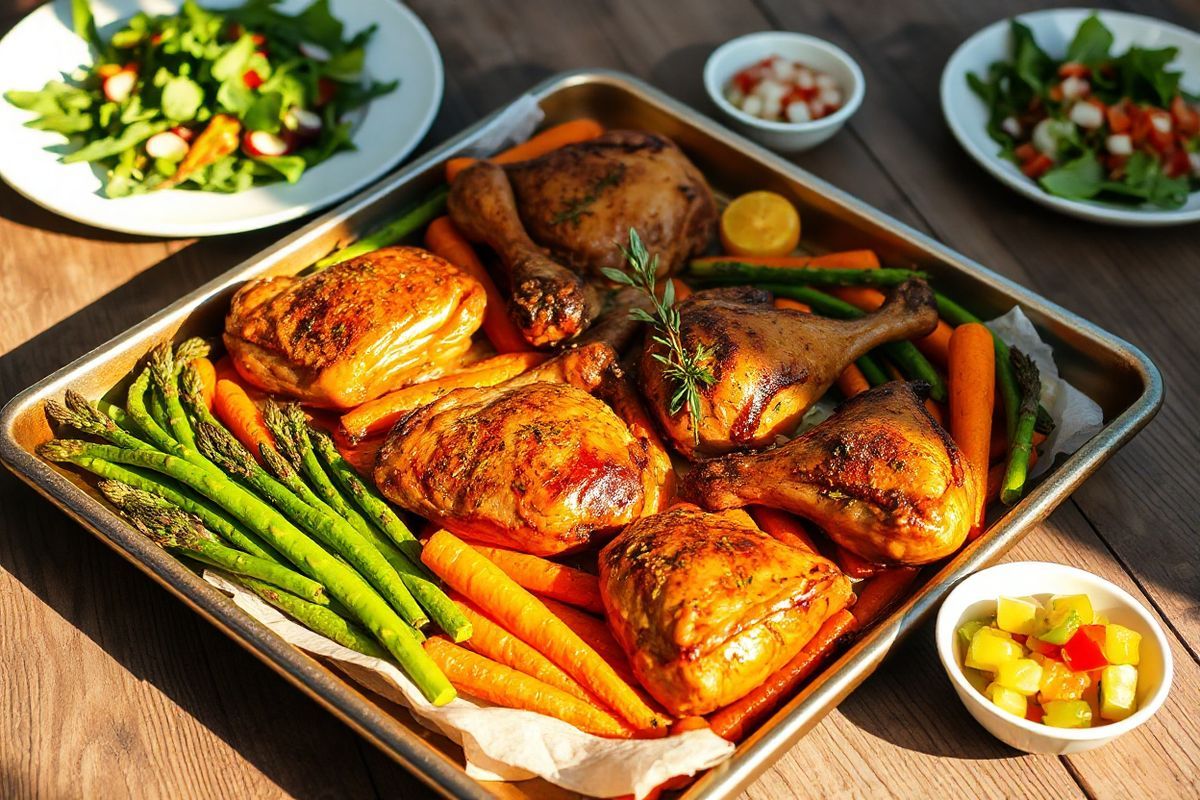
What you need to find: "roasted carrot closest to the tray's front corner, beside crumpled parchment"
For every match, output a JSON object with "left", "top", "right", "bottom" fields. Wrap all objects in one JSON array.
[{"left": 425, "top": 636, "right": 634, "bottom": 739}]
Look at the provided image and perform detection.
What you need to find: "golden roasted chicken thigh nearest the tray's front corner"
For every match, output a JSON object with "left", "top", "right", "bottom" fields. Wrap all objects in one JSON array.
[{"left": 600, "top": 504, "right": 853, "bottom": 716}]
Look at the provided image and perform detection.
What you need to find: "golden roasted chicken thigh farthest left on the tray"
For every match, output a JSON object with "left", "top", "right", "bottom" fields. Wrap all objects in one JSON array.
[{"left": 224, "top": 247, "right": 486, "bottom": 408}]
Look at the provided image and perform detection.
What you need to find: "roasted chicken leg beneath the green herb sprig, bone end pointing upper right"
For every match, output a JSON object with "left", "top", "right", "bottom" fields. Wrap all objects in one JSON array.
[{"left": 641, "top": 281, "right": 937, "bottom": 458}]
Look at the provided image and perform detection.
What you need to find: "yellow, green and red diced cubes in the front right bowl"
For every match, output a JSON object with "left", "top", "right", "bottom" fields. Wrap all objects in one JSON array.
[{"left": 958, "top": 595, "right": 1141, "bottom": 728}]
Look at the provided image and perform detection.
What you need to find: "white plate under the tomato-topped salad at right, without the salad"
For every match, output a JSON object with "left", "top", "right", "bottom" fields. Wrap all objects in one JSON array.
[{"left": 941, "top": 8, "right": 1200, "bottom": 225}]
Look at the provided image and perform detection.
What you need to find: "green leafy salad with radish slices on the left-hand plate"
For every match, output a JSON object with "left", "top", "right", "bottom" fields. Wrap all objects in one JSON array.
[{"left": 5, "top": 0, "right": 397, "bottom": 198}]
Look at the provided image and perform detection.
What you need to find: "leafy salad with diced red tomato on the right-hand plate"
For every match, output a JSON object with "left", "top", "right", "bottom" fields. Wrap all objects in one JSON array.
[{"left": 967, "top": 14, "right": 1200, "bottom": 209}]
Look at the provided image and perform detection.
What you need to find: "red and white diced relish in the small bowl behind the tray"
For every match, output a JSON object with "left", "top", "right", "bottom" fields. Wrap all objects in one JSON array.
[{"left": 725, "top": 55, "right": 846, "bottom": 122}]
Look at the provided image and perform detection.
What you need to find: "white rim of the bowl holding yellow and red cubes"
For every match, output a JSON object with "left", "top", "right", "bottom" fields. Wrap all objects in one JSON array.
[{"left": 934, "top": 561, "right": 1175, "bottom": 741}]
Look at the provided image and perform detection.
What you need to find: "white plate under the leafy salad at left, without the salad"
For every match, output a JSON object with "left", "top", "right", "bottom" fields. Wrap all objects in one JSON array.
[{"left": 0, "top": 0, "right": 443, "bottom": 236}]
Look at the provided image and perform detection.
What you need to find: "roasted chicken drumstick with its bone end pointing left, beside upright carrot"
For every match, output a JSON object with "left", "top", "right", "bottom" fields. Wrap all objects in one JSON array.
[{"left": 683, "top": 381, "right": 983, "bottom": 564}]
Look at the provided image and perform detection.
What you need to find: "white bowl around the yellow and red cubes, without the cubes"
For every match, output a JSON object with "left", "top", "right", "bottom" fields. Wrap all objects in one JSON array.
[{"left": 935, "top": 561, "right": 1174, "bottom": 754}]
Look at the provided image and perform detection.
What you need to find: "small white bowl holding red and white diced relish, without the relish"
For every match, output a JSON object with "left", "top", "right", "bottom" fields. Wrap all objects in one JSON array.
[{"left": 704, "top": 31, "right": 866, "bottom": 152}]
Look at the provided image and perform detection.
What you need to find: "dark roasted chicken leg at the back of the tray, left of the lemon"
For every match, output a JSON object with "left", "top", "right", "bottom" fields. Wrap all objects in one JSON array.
[{"left": 449, "top": 131, "right": 716, "bottom": 347}]
